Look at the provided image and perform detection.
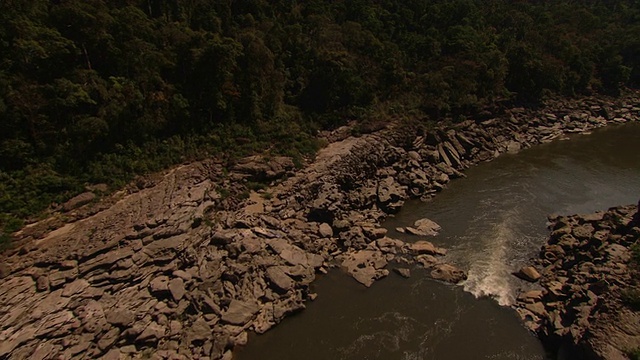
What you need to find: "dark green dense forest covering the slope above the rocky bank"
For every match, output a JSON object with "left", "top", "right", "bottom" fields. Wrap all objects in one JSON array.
[{"left": 0, "top": 0, "right": 640, "bottom": 245}]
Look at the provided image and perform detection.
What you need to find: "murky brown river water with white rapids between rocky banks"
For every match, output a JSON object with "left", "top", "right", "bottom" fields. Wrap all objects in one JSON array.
[{"left": 235, "top": 124, "right": 640, "bottom": 360}]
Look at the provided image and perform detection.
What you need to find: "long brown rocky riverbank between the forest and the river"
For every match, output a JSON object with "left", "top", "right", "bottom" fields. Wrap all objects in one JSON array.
[{"left": 0, "top": 94, "right": 640, "bottom": 359}]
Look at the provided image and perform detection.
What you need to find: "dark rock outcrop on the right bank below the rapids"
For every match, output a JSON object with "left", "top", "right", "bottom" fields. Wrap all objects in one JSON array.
[{"left": 515, "top": 206, "right": 640, "bottom": 359}]
